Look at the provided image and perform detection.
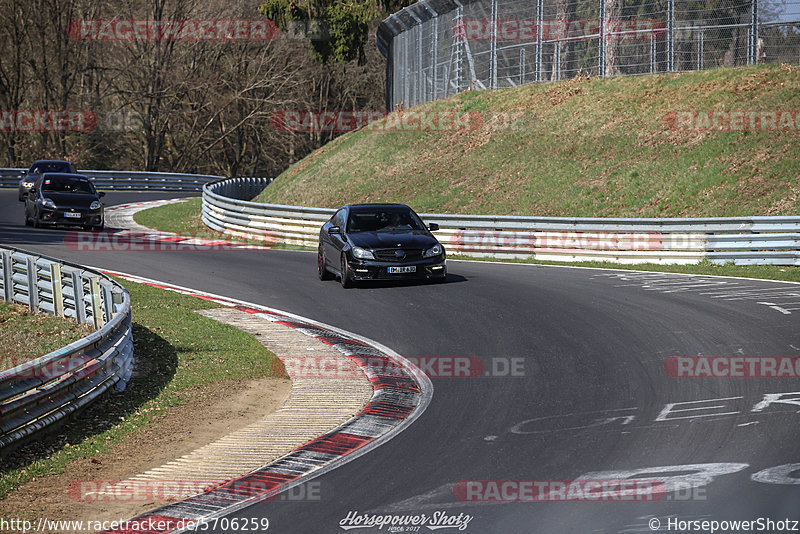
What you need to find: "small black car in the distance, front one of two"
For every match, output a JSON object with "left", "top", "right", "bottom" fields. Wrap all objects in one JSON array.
[{"left": 25, "top": 173, "right": 105, "bottom": 230}]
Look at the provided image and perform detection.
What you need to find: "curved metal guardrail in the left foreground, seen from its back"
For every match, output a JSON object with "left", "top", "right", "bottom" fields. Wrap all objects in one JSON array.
[{"left": 0, "top": 247, "right": 133, "bottom": 449}]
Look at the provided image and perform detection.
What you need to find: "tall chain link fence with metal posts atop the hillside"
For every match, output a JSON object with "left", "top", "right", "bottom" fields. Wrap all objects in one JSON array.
[{"left": 377, "top": 0, "right": 800, "bottom": 110}]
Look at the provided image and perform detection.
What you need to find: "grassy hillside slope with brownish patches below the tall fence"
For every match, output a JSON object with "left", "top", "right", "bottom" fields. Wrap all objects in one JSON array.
[{"left": 258, "top": 66, "right": 800, "bottom": 217}]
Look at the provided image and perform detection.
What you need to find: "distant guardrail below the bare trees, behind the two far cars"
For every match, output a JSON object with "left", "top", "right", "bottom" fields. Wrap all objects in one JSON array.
[{"left": 0, "top": 168, "right": 223, "bottom": 192}]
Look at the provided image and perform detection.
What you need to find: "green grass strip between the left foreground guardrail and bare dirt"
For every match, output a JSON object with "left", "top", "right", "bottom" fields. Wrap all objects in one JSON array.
[{"left": 0, "top": 281, "right": 282, "bottom": 499}]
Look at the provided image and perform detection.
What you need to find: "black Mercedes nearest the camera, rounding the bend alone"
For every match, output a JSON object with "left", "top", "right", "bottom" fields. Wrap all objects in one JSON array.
[{"left": 317, "top": 204, "right": 447, "bottom": 288}]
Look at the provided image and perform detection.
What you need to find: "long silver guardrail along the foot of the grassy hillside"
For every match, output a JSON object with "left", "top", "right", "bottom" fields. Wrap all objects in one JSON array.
[{"left": 202, "top": 178, "right": 800, "bottom": 265}]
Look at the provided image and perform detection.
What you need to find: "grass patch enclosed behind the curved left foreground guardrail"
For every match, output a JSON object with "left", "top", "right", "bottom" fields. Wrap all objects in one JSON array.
[{"left": 0, "top": 301, "right": 92, "bottom": 371}]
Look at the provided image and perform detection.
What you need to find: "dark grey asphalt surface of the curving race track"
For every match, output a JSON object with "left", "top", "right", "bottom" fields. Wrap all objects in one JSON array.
[{"left": 0, "top": 190, "right": 800, "bottom": 534}]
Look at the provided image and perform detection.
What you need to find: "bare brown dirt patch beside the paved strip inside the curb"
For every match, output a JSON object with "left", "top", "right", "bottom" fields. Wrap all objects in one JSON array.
[{"left": 0, "top": 378, "right": 291, "bottom": 532}]
